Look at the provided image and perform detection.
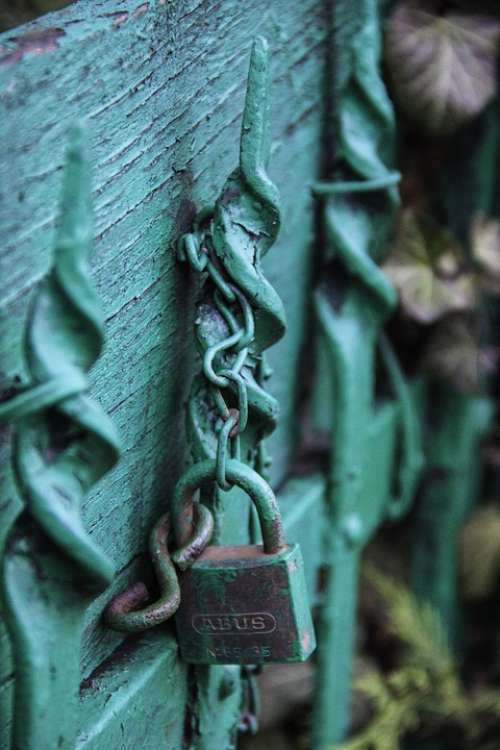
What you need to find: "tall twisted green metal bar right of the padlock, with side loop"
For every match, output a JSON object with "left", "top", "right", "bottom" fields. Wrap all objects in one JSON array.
[{"left": 313, "top": 0, "right": 421, "bottom": 750}]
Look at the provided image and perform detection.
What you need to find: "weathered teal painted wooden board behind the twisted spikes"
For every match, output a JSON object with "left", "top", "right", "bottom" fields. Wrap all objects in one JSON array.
[{"left": 0, "top": 0, "right": 328, "bottom": 749}]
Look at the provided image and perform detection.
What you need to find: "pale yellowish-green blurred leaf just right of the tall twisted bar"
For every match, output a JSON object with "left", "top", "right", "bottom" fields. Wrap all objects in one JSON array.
[{"left": 383, "top": 210, "right": 475, "bottom": 323}]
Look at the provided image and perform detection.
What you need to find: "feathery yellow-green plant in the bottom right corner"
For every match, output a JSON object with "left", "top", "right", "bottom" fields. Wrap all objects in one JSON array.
[{"left": 337, "top": 567, "right": 500, "bottom": 750}]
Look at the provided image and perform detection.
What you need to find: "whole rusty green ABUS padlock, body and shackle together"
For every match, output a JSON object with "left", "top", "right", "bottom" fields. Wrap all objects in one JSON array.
[{"left": 172, "top": 459, "right": 316, "bottom": 664}]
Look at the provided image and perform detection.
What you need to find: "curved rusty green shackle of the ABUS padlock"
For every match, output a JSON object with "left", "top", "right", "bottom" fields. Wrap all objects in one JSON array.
[{"left": 171, "top": 458, "right": 285, "bottom": 555}]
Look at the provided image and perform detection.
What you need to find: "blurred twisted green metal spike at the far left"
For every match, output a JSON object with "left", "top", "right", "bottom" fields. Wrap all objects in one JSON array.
[{"left": 0, "top": 126, "right": 119, "bottom": 750}]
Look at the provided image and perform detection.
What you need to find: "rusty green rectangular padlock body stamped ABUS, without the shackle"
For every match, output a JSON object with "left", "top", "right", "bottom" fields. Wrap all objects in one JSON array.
[{"left": 176, "top": 544, "right": 316, "bottom": 664}]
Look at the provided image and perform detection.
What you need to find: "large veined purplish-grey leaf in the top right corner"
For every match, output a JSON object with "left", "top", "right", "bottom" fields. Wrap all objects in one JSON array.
[{"left": 385, "top": 0, "right": 500, "bottom": 134}]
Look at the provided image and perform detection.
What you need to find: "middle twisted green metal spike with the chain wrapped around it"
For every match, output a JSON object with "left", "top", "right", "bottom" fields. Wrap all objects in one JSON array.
[{"left": 180, "top": 37, "right": 285, "bottom": 494}]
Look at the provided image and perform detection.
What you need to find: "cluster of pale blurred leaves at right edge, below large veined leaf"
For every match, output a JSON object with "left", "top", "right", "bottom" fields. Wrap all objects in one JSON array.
[{"left": 383, "top": 208, "right": 500, "bottom": 393}]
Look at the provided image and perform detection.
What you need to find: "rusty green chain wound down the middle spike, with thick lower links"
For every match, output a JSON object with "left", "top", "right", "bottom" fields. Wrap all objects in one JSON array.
[{"left": 104, "top": 219, "right": 262, "bottom": 632}]
